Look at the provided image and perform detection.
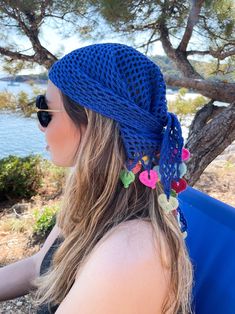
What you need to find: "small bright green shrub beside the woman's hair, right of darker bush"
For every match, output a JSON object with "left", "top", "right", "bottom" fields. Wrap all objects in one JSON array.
[{"left": 33, "top": 205, "right": 59, "bottom": 237}]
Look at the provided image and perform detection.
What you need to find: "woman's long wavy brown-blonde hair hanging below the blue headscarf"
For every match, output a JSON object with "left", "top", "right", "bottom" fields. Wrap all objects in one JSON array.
[{"left": 34, "top": 93, "right": 193, "bottom": 314}]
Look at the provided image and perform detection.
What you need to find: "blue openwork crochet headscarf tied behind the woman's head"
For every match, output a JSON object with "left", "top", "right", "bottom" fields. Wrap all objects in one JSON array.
[{"left": 49, "top": 43, "right": 189, "bottom": 236}]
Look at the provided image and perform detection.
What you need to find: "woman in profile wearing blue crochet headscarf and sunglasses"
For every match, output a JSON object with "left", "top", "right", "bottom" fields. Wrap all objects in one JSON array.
[{"left": 0, "top": 44, "right": 192, "bottom": 314}]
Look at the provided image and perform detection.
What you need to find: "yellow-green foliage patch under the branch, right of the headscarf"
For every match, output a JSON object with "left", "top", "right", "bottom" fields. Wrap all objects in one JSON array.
[{"left": 168, "top": 94, "right": 209, "bottom": 115}]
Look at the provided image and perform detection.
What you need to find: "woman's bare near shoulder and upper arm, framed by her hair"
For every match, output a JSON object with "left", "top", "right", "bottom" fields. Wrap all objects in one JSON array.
[{"left": 58, "top": 219, "right": 169, "bottom": 314}]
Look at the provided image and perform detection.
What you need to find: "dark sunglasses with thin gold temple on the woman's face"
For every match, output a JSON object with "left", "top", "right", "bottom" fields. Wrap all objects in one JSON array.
[{"left": 36, "top": 95, "right": 64, "bottom": 128}]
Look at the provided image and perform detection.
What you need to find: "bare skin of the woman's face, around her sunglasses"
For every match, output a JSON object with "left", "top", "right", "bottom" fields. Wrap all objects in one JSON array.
[{"left": 38, "top": 80, "right": 85, "bottom": 167}]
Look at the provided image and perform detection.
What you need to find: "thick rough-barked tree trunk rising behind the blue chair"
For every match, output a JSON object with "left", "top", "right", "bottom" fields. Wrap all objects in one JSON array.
[{"left": 185, "top": 101, "right": 235, "bottom": 186}]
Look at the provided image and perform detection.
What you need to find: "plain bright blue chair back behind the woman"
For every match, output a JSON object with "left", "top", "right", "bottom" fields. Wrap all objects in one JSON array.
[{"left": 179, "top": 187, "right": 235, "bottom": 314}]
